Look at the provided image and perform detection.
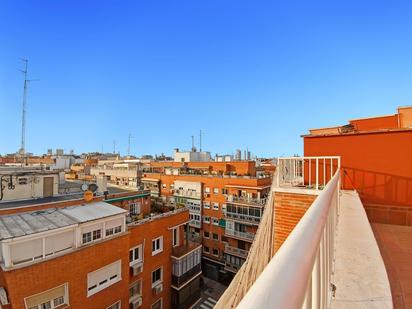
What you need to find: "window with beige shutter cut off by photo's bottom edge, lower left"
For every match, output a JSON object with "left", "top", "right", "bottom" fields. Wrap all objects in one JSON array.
[{"left": 24, "top": 283, "right": 69, "bottom": 309}]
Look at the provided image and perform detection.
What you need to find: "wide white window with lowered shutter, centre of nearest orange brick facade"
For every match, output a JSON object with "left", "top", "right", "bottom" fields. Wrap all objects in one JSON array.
[{"left": 87, "top": 260, "right": 122, "bottom": 297}]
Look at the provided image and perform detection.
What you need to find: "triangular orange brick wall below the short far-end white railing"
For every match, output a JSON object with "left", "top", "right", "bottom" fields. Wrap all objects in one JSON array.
[{"left": 273, "top": 192, "right": 317, "bottom": 252}]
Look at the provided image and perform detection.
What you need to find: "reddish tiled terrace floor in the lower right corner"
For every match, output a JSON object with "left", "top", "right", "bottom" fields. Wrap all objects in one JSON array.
[{"left": 371, "top": 223, "right": 412, "bottom": 309}]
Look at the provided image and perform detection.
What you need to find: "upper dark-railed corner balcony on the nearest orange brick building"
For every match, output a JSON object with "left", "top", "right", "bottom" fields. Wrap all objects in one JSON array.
[{"left": 172, "top": 241, "right": 202, "bottom": 289}]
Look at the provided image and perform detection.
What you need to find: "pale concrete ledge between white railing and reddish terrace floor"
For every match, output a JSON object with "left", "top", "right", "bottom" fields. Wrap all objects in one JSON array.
[{"left": 331, "top": 191, "right": 392, "bottom": 309}]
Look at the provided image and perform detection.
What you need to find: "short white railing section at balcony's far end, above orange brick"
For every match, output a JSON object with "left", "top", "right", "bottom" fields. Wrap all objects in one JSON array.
[{"left": 276, "top": 156, "right": 340, "bottom": 190}]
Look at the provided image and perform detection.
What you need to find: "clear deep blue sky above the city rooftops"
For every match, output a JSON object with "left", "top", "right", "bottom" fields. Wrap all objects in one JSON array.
[{"left": 0, "top": 0, "right": 412, "bottom": 156}]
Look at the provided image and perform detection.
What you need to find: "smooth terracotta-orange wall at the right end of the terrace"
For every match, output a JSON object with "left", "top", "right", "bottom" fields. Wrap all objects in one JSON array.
[{"left": 304, "top": 131, "right": 412, "bottom": 224}]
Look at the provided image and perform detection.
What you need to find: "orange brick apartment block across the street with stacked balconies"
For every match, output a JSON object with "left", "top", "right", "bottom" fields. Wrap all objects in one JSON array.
[{"left": 142, "top": 161, "right": 272, "bottom": 282}]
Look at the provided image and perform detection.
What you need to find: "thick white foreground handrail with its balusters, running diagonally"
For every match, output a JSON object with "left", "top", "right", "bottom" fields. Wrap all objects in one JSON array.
[{"left": 237, "top": 170, "right": 340, "bottom": 309}]
